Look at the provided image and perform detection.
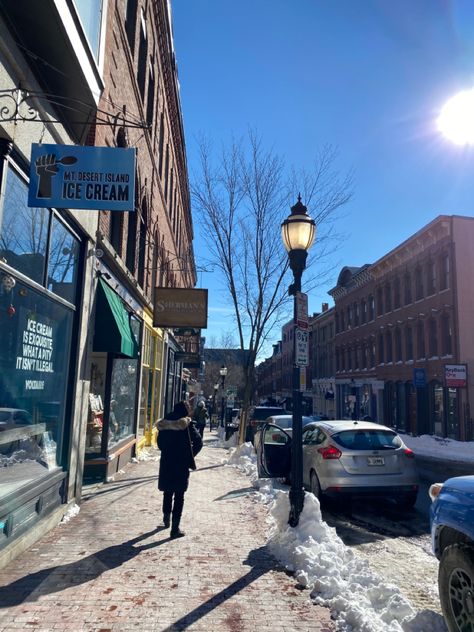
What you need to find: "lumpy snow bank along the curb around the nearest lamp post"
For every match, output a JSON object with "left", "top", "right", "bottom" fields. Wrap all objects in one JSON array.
[{"left": 227, "top": 443, "right": 446, "bottom": 632}]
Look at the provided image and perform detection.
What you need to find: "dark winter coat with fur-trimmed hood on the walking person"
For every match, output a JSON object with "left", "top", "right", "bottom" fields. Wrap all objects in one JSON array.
[{"left": 157, "top": 417, "right": 202, "bottom": 492}]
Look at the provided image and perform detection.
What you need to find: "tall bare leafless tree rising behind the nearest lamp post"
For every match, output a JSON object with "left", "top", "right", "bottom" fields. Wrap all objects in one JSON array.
[{"left": 191, "top": 132, "right": 352, "bottom": 441}]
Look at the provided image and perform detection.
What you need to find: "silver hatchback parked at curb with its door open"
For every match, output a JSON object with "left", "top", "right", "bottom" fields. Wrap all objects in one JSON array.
[{"left": 255, "top": 420, "right": 418, "bottom": 508}]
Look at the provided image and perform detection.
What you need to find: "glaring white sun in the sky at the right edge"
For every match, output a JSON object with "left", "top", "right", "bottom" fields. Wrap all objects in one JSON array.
[{"left": 437, "top": 89, "right": 474, "bottom": 145}]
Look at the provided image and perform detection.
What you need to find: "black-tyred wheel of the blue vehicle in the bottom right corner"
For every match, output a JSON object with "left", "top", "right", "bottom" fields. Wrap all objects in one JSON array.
[{"left": 438, "top": 544, "right": 474, "bottom": 632}]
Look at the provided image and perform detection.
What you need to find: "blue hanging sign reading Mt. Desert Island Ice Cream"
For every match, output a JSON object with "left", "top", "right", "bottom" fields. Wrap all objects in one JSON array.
[{"left": 28, "top": 143, "right": 135, "bottom": 211}]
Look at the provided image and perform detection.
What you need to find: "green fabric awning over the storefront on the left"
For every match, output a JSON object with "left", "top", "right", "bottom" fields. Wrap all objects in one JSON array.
[{"left": 93, "top": 279, "right": 138, "bottom": 358}]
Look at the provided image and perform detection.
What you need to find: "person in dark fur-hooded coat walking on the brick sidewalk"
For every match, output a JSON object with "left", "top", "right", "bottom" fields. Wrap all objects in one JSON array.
[{"left": 157, "top": 402, "right": 202, "bottom": 538}]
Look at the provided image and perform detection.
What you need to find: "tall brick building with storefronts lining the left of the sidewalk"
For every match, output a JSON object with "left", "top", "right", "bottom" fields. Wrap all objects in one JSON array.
[{"left": 0, "top": 0, "right": 199, "bottom": 565}]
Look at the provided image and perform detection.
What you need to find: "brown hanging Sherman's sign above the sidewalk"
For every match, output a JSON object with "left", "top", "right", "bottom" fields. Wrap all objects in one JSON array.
[{"left": 153, "top": 287, "right": 207, "bottom": 329}]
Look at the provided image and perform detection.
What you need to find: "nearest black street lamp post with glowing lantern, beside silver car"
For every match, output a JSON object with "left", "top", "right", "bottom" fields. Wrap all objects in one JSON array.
[{"left": 281, "top": 196, "right": 316, "bottom": 527}]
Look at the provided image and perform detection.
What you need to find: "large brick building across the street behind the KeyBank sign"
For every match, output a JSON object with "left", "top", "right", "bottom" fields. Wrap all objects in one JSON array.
[{"left": 329, "top": 215, "right": 474, "bottom": 440}]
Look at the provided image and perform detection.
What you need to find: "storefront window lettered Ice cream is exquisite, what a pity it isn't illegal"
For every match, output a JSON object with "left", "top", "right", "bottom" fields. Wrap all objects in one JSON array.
[{"left": 0, "top": 270, "right": 73, "bottom": 498}]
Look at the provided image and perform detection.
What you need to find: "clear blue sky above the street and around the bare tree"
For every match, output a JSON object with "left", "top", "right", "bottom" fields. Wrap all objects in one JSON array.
[{"left": 172, "top": 0, "right": 474, "bottom": 354}]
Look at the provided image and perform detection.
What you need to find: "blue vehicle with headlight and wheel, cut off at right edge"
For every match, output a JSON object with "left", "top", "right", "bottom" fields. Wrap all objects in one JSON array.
[{"left": 429, "top": 476, "right": 474, "bottom": 632}]
